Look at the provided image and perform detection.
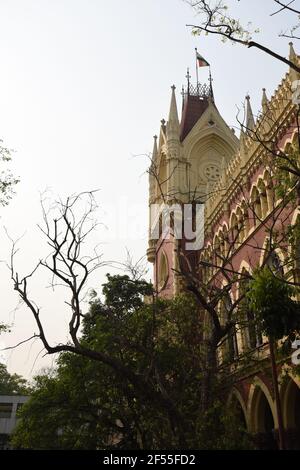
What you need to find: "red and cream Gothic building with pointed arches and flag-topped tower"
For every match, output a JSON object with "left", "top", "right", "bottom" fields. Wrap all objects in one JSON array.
[{"left": 147, "top": 44, "right": 300, "bottom": 449}]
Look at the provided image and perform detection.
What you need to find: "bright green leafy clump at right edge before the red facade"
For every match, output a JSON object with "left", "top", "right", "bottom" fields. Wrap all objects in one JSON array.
[{"left": 247, "top": 267, "right": 300, "bottom": 339}]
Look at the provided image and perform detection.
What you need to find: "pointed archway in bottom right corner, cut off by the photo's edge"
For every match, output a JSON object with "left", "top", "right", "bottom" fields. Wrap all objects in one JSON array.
[{"left": 281, "top": 377, "right": 300, "bottom": 450}]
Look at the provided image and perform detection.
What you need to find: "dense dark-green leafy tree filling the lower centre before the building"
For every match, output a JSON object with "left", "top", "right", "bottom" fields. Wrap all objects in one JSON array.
[{"left": 13, "top": 276, "right": 251, "bottom": 449}]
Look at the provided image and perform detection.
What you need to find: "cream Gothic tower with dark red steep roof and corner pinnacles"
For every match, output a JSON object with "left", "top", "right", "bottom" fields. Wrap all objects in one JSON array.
[{"left": 147, "top": 73, "right": 239, "bottom": 297}]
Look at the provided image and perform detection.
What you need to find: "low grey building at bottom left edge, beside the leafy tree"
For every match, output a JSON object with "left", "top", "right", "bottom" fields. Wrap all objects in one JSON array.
[{"left": 0, "top": 395, "right": 28, "bottom": 450}]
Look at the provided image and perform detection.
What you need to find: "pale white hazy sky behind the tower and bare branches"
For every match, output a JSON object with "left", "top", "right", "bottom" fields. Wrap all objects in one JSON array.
[{"left": 0, "top": 0, "right": 299, "bottom": 377}]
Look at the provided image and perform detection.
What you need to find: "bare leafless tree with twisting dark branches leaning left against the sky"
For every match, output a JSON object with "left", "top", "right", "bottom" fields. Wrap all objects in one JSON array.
[{"left": 9, "top": 191, "right": 197, "bottom": 446}]
